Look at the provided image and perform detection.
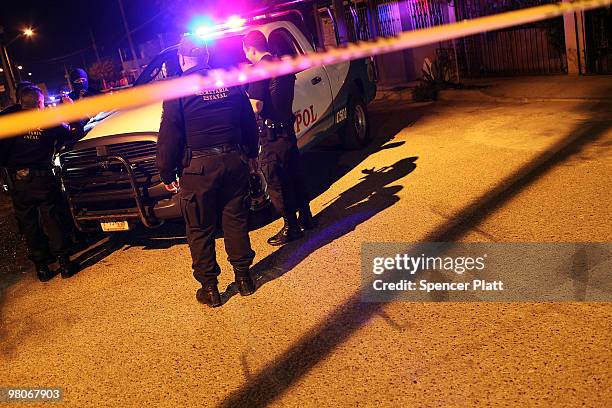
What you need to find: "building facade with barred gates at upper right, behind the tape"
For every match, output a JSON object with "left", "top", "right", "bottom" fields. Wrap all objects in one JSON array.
[{"left": 334, "top": 0, "right": 612, "bottom": 86}]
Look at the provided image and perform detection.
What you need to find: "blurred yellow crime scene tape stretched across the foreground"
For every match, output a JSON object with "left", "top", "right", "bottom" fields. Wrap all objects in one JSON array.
[{"left": 0, "top": 0, "right": 612, "bottom": 139}]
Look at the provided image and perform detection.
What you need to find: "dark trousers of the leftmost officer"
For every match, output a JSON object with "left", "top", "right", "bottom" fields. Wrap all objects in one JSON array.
[{"left": 11, "top": 170, "right": 70, "bottom": 263}]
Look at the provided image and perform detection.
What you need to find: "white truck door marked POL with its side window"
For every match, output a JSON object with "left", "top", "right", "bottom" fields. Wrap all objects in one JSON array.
[{"left": 268, "top": 27, "right": 334, "bottom": 138}]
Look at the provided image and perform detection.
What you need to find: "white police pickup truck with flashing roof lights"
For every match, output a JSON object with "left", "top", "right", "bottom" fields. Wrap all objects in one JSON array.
[{"left": 56, "top": 6, "right": 376, "bottom": 231}]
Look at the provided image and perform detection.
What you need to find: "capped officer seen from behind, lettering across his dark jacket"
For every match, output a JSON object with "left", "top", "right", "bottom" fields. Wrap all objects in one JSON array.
[{"left": 157, "top": 36, "right": 258, "bottom": 307}]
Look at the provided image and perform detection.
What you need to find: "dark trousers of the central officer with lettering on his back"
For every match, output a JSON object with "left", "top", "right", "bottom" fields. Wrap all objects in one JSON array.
[{"left": 179, "top": 151, "right": 255, "bottom": 286}]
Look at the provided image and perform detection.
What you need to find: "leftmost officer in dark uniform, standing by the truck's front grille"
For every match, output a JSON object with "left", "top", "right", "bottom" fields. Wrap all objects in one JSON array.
[{"left": 0, "top": 86, "right": 83, "bottom": 282}]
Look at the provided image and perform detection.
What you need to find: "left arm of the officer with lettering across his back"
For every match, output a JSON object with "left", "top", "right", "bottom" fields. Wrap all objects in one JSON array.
[{"left": 156, "top": 100, "right": 185, "bottom": 185}]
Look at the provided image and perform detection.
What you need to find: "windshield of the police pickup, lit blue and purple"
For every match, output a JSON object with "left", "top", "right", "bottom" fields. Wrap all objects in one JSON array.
[{"left": 134, "top": 35, "right": 247, "bottom": 86}]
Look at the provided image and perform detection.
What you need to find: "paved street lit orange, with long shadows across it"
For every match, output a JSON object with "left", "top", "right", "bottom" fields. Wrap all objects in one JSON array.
[{"left": 0, "top": 91, "right": 612, "bottom": 407}]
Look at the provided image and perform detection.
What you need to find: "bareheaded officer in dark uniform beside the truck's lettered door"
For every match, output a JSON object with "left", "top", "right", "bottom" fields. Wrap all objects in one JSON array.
[{"left": 243, "top": 31, "right": 314, "bottom": 246}]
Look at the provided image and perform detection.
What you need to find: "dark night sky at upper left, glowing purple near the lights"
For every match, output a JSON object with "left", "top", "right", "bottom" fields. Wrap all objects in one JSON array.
[{"left": 0, "top": 0, "right": 257, "bottom": 93}]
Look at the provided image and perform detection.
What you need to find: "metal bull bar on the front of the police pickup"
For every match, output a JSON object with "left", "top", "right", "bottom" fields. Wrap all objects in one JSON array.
[{"left": 60, "top": 155, "right": 163, "bottom": 232}]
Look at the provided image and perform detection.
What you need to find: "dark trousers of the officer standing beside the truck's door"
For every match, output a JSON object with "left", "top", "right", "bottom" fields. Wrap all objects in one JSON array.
[{"left": 259, "top": 133, "right": 309, "bottom": 217}]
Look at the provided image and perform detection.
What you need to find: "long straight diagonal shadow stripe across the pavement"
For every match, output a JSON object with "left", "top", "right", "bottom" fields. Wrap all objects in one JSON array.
[{"left": 219, "top": 99, "right": 612, "bottom": 408}]
